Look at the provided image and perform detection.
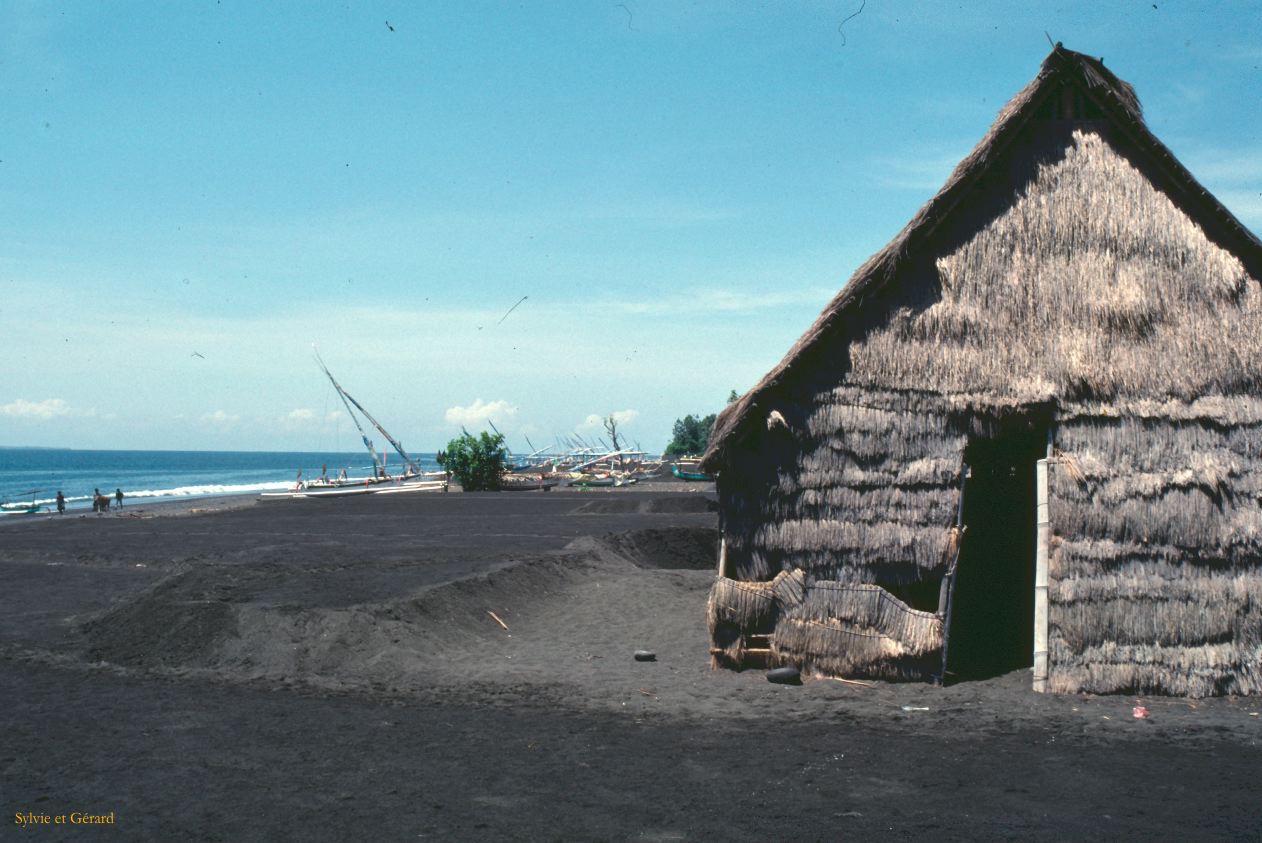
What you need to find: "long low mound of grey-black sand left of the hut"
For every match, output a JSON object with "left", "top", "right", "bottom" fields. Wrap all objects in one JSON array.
[{"left": 81, "top": 530, "right": 714, "bottom": 704}]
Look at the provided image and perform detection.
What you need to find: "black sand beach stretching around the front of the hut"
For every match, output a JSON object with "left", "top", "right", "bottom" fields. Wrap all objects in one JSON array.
[{"left": 0, "top": 482, "right": 1262, "bottom": 840}]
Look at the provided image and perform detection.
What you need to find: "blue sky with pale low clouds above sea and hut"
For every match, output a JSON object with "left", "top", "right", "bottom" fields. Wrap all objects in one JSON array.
[{"left": 0, "top": 0, "right": 1262, "bottom": 451}]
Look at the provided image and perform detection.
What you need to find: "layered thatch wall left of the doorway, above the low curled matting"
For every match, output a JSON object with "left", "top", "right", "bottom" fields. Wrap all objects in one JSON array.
[{"left": 719, "top": 389, "right": 965, "bottom": 583}]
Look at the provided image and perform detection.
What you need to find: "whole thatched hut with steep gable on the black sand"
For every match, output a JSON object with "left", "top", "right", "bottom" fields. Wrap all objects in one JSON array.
[{"left": 703, "top": 44, "right": 1262, "bottom": 695}]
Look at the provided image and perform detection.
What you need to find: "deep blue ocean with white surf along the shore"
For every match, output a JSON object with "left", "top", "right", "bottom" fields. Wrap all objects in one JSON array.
[{"left": 0, "top": 448, "right": 439, "bottom": 509}]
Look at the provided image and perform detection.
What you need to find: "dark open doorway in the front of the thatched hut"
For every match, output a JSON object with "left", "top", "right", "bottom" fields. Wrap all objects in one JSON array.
[{"left": 947, "top": 425, "right": 1047, "bottom": 680}]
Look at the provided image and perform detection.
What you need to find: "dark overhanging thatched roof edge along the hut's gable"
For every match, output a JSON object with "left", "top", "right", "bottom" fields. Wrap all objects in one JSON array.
[{"left": 703, "top": 44, "right": 1262, "bottom": 468}]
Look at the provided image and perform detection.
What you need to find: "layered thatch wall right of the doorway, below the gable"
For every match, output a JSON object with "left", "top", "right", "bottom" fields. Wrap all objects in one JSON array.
[{"left": 1049, "top": 416, "right": 1262, "bottom": 697}]
